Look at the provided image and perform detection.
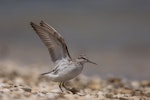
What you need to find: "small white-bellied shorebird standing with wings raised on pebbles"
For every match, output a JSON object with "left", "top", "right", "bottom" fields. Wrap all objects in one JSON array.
[{"left": 30, "top": 21, "right": 96, "bottom": 92}]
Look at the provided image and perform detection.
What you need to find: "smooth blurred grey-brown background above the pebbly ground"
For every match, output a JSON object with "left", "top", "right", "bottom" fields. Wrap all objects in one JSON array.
[{"left": 0, "top": 0, "right": 150, "bottom": 80}]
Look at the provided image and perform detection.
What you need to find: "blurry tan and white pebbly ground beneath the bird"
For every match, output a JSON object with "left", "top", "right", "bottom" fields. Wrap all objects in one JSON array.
[{"left": 0, "top": 61, "right": 150, "bottom": 100}]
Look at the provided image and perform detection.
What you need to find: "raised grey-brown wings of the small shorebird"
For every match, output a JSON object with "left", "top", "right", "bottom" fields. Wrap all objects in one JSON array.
[{"left": 30, "top": 21, "right": 71, "bottom": 62}]
